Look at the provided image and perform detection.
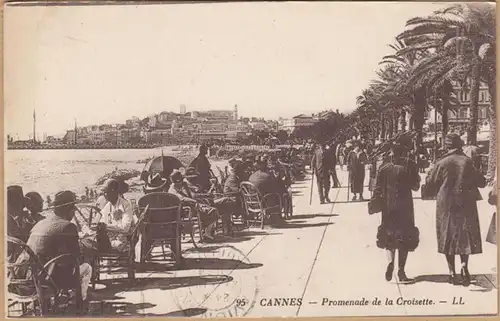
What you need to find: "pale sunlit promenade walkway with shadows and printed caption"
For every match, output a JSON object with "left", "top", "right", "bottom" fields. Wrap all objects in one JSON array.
[{"left": 91, "top": 171, "right": 497, "bottom": 317}]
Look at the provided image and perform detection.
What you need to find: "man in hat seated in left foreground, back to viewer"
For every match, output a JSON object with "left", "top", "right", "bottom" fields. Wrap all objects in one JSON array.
[{"left": 27, "top": 191, "right": 92, "bottom": 301}]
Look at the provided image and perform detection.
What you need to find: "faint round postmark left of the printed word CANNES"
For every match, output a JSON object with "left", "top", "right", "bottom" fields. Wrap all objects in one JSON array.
[{"left": 171, "top": 244, "right": 260, "bottom": 318}]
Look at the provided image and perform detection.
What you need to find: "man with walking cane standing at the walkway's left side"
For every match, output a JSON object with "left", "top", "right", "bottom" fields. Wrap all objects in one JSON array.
[{"left": 311, "top": 143, "right": 332, "bottom": 204}]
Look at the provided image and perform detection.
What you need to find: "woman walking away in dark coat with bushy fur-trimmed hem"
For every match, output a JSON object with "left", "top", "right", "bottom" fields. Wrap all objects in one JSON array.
[{"left": 372, "top": 143, "right": 420, "bottom": 282}]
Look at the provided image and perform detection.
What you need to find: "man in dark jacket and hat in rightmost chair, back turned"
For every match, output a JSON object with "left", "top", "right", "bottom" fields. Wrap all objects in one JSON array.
[{"left": 248, "top": 156, "right": 287, "bottom": 214}]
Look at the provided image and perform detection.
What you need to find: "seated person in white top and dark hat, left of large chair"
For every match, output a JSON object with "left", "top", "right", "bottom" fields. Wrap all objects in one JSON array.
[{"left": 98, "top": 179, "right": 134, "bottom": 252}]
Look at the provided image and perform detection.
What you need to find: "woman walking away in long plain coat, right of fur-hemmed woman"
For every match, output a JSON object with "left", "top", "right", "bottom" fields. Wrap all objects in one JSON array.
[{"left": 426, "top": 134, "right": 486, "bottom": 286}]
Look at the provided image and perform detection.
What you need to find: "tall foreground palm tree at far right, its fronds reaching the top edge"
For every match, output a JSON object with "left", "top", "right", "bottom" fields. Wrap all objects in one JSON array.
[{"left": 397, "top": 3, "right": 496, "bottom": 144}]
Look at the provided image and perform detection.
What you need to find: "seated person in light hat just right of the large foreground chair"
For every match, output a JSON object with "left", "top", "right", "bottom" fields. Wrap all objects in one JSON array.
[{"left": 168, "top": 169, "right": 219, "bottom": 241}]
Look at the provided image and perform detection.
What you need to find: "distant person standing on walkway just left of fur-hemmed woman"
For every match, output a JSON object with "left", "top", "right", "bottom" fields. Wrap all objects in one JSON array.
[{"left": 347, "top": 141, "right": 368, "bottom": 201}]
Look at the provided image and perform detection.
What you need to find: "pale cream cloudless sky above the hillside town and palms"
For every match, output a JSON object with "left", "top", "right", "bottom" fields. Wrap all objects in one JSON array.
[{"left": 4, "top": 2, "right": 444, "bottom": 139}]
